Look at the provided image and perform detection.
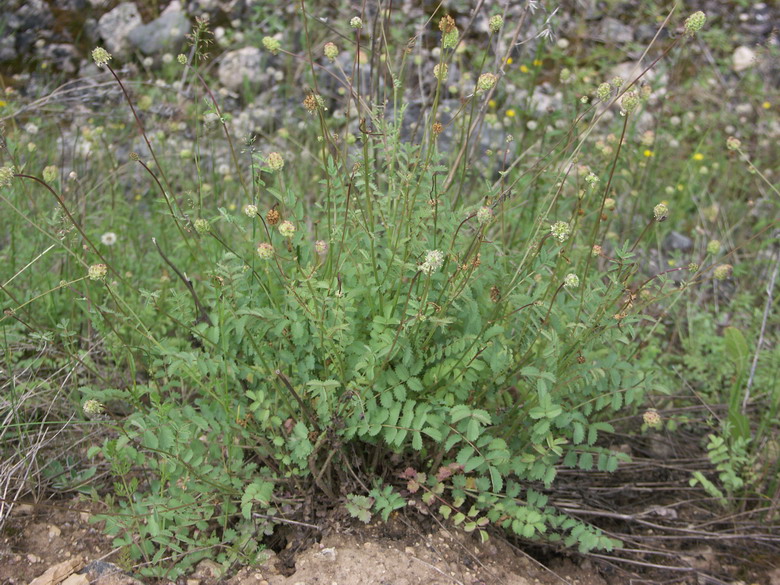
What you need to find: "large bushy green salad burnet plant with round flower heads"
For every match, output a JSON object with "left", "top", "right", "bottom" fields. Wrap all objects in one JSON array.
[{"left": 3, "top": 6, "right": 704, "bottom": 576}]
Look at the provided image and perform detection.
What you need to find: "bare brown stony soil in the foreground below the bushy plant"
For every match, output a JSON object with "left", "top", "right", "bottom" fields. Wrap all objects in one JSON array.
[{"left": 0, "top": 500, "right": 620, "bottom": 585}]
